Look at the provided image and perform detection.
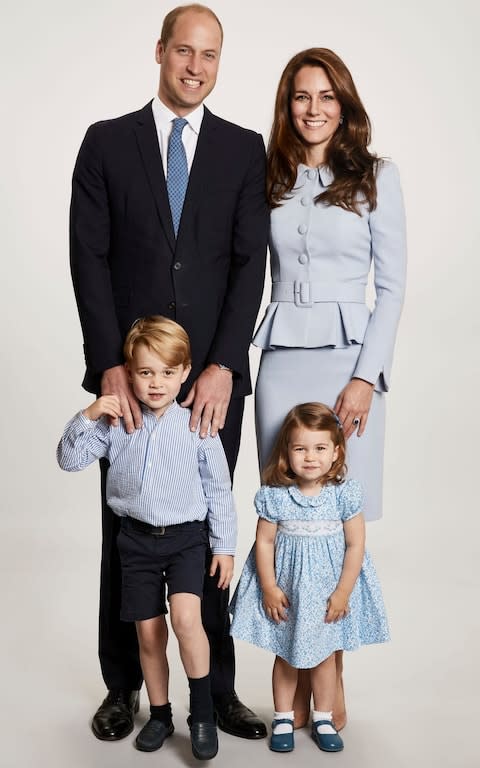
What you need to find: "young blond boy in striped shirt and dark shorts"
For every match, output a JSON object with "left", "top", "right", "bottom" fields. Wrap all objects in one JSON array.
[{"left": 57, "top": 316, "right": 236, "bottom": 760}]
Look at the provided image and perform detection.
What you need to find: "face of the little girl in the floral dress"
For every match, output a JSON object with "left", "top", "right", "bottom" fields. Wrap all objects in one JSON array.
[{"left": 288, "top": 427, "right": 338, "bottom": 492}]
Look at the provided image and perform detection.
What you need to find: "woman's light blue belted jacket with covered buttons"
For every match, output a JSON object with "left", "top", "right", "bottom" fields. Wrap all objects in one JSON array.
[{"left": 253, "top": 161, "right": 406, "bottom": 391}]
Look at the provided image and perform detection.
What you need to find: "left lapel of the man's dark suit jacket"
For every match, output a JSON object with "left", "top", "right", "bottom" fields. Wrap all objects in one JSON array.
[{"left": 135, "top": 102, "right": 176, "bottom": 252}]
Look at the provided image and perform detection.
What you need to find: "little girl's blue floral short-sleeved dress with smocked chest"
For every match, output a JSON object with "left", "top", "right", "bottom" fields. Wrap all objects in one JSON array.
[{"left": 229, "top": 480, "right": 389, "bottom": 669}]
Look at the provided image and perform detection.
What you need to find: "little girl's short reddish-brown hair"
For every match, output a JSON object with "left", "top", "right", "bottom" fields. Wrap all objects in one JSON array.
[{"left": 262, "top": 403, "right": 347, "bottom": 486}]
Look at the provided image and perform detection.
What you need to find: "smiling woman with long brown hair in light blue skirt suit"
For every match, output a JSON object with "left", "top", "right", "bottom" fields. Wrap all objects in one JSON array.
[{"left": 254, "top": 48, "right": 406, "bottom": 729}]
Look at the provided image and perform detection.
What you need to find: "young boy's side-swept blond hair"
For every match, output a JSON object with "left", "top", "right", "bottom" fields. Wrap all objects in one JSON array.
[{"left": 123, "top": 315, "right": 192, "bottom": 368}]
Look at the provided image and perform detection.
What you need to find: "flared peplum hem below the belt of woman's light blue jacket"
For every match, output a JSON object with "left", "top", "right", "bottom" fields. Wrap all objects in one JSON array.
[{"left": 252, "top": 302, "right": 370, "bottom": 350}]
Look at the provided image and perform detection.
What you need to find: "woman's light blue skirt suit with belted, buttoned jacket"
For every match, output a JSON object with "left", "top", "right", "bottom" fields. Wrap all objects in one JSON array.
[{"left": 253, "top": 161, "right": 406, "bottom": 520}]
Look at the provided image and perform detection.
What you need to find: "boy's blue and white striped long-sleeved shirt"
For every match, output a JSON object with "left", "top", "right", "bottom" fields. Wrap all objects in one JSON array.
[{"left": 57, "top": 402, "right": 237, "bottom": 554}]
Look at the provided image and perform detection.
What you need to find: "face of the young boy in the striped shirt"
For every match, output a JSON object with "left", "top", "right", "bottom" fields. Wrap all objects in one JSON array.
[{"left": 126, "top": 344, "right": 191, "bottom": 418}]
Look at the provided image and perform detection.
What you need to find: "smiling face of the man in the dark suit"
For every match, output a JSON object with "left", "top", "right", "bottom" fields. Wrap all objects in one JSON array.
[{"left": 155, "top": 11, "right": 222, "bottom": 117}]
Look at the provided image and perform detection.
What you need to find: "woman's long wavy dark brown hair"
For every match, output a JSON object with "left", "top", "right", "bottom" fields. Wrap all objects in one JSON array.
[{"left": 267, "top": 48, "right": 379, "bottom": 214}]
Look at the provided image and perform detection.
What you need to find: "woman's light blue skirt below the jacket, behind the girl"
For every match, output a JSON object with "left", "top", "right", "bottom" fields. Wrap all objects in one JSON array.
[{"left": 255, "top": 344, "right": 385, "bottom": 520}]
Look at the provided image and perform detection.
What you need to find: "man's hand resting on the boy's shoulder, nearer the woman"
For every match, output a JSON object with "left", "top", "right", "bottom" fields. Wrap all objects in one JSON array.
[{"left": 182, "top": 365, "right": 233, "bottom": 437}]
